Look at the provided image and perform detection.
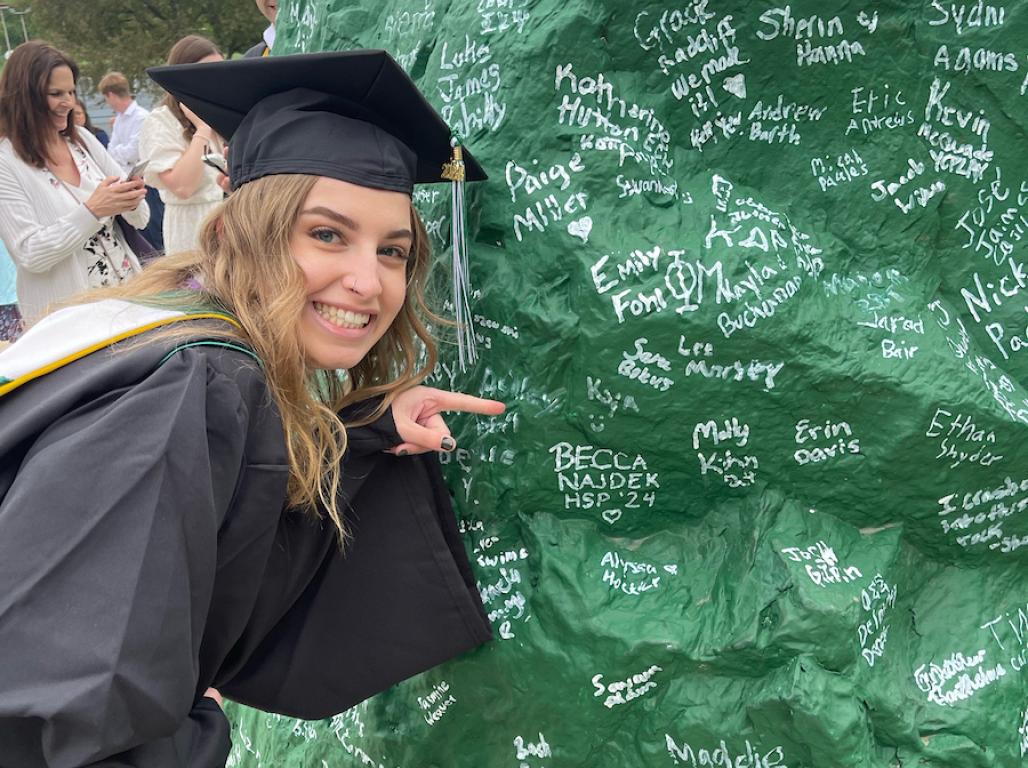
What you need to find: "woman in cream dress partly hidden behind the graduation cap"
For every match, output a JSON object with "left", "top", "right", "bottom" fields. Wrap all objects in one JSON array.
[{"left": 139, "top": 35, "right": 226, "bottom": 254}]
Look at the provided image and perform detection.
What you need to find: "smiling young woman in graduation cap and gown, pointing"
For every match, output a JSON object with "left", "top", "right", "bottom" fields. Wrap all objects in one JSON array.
[{"left": 0, "top": 51, "right": 504, "bottom": 768}]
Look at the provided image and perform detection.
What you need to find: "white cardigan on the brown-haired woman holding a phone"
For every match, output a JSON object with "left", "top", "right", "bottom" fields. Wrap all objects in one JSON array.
[{"left": 0, "top": 130, "right": 150, "bottom": 323}]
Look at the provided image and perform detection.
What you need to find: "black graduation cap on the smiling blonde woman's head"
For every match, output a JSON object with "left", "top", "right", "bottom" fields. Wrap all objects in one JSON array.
[{"left": 147, "top": 50, "right": 486, "bottom": 194}]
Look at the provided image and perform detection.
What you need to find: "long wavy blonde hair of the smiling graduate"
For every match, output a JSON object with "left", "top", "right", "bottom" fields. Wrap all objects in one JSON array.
[{"left": 92, "top": 175, "right": 440, "bottom": 540}]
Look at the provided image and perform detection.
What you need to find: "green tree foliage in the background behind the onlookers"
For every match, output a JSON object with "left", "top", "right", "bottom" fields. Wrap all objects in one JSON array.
[{"left": 10, "top": 0, "right": 267, "bottom": 84}]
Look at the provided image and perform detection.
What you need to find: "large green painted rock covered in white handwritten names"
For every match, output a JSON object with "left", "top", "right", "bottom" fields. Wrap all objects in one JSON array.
[{"left": 230, "top": 0, "right": 1028, "bottom": 768}]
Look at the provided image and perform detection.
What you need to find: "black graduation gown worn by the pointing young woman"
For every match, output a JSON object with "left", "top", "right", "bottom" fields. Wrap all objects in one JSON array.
[{"left": 0, "top": 337, "right": 490, "bottom": 768}]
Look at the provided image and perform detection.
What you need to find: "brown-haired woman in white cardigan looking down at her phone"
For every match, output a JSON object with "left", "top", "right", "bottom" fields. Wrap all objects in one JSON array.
[{"left": 0, "top": 40, "right": 150, "bottom": 324}]
